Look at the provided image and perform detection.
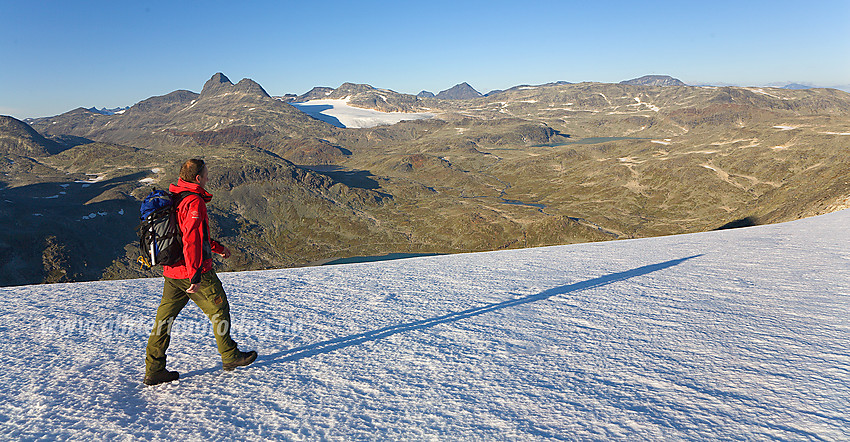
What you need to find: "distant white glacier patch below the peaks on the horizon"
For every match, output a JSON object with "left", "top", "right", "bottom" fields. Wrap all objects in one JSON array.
[{"left": 291, "top": 97, "right": 434, "bottom": 128}]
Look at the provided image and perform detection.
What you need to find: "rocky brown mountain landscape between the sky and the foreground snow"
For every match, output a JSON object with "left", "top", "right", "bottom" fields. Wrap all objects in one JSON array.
[{"left": 0, "top": 73, "right": 850, "bottom": 285}]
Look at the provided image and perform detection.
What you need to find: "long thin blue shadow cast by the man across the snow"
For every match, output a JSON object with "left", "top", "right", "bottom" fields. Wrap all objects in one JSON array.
[{"left": 182, "top": 255, "right": 702, "bottom": 378}]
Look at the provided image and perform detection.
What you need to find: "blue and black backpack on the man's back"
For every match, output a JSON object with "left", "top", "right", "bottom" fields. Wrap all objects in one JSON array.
[{"left": 137, "top": 190, "right": 200, "bottom": 268}]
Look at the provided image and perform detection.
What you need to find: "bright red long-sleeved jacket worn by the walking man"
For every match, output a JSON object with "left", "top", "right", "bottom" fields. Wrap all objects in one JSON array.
[{"left": 162, "top": 179, "right": 224, "bottom": 284}]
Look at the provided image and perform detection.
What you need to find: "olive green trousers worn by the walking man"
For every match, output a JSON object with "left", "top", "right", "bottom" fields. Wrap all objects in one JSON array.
[{"left": 145, "top": 271, "right": 238, "bottom": 375}]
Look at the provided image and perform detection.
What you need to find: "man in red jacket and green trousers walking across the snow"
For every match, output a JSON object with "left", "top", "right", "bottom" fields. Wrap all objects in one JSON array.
[{"left": 144, "top": 159, "right": 257, "bottom": 385}]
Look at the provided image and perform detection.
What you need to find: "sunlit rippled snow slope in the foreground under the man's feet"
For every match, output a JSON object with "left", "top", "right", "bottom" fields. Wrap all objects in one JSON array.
[{"left": 0, "top": 211, "right": 850, "bottom": 440}]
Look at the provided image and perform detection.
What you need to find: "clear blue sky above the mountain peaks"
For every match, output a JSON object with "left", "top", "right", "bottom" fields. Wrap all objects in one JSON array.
[{"left": 0, "top": 0, "right": 850, "bottom": 118}]
